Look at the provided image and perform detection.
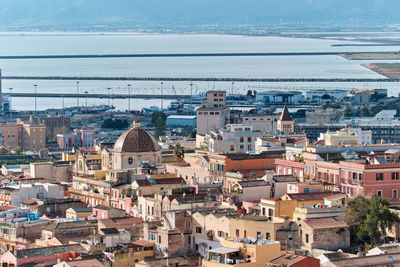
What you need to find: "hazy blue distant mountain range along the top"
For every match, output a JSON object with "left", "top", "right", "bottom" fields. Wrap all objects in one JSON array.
[{"left": 0, "top": 0, "right": 400, "bottom": 30}]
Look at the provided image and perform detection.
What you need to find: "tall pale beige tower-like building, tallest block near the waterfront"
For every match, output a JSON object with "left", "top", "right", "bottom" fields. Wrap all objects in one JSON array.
[{"left": 197, "top": 91, "right": 229, "bottom": 135}]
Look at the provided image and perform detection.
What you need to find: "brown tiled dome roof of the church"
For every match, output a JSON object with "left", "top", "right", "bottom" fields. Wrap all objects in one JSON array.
[{"left": 113, "top": 127, "right": 160, "bottom": 152}]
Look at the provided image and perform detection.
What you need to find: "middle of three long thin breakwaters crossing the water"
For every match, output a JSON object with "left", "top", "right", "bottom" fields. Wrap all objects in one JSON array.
[{"left": 0, "top": 76, "right": 400, "bottom": 83}]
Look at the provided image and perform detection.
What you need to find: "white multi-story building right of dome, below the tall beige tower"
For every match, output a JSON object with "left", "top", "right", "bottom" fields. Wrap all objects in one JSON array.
[{"left": 204, "top": 124, "right": 262, "bottom": 153}]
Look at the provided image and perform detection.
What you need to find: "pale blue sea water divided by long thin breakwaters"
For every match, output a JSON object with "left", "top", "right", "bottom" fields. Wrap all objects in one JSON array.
[{"left": 0, "top": 32, "right": 400, "bottom": 110}]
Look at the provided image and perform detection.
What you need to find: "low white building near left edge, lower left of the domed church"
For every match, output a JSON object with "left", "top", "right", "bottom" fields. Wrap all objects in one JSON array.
[{"left": 6, "top": 183, "right": 64, "bottom": 207}]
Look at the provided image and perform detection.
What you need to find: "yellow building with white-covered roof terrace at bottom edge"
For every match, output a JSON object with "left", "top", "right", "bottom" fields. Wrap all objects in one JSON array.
[{"left": 202, "top": 238, "right": 283, "bottom": 267}]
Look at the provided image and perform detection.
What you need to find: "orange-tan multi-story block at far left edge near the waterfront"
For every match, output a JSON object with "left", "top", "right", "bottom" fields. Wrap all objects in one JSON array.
[{"left": 0, "top": 117, "right": 46, "bottom": 151}]
